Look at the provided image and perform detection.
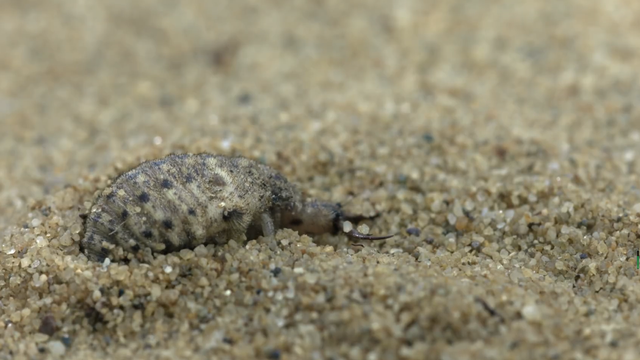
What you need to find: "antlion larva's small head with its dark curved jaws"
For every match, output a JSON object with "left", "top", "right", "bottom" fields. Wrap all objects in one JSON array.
[{"left": 281, "top": 200, "right": 393, "bottom": 240}]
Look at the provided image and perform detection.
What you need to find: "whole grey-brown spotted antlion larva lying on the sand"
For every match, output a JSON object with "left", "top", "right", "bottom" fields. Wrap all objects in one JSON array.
[{"left": 81, "top": 154, "right": 393, "bottom": 261}]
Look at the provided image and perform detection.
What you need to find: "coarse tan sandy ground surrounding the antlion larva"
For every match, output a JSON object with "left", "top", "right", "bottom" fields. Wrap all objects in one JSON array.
[{"left": 0, "top": 0, "right": 640, "bottom": 360}]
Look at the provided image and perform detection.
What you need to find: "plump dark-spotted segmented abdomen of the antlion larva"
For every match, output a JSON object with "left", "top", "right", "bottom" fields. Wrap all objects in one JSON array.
[{"left": 82, "top": 154, "right": 252, "bottom": 261}]
